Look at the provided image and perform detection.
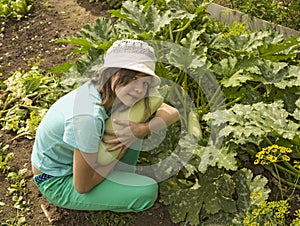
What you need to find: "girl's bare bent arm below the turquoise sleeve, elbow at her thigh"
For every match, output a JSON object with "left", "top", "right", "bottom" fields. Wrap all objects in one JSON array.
[{"left": 73, "top": 148, "right": 125, "bottom": 194}]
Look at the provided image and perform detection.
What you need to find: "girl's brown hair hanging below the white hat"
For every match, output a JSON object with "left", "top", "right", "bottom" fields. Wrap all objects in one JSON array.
[{"left": 92, "top": 68, "right": 150, "bottom": 112}]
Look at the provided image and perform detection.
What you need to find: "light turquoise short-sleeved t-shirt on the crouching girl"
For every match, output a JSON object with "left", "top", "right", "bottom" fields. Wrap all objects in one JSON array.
[{"left": 31, "top": 82, "right": 108, "bottom": 176}]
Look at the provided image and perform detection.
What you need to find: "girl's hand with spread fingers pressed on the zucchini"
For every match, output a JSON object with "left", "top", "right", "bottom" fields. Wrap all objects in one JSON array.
[{"left": 103, "top": 119, "right": 150, "bottom": 151}]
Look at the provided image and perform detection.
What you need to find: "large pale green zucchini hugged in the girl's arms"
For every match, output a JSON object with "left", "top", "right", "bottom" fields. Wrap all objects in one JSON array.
[{"left": 97, "top": 88, "right": 163, "bottom": 165}]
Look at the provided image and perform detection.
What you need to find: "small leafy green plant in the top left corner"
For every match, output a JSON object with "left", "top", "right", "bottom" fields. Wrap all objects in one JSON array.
[{"left": 0, "top": 0, "right": 34, "bottom": 20}]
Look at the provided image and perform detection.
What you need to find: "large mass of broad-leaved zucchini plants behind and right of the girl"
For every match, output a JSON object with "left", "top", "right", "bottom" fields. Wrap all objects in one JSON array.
[{"left": 52, "top": 0, "right": 300, "bottom": 225}]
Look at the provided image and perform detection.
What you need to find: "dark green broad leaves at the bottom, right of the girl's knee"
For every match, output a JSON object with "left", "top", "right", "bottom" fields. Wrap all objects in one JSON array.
[{"left": 161, "top": 168, "right": 270, "bottom": 225}]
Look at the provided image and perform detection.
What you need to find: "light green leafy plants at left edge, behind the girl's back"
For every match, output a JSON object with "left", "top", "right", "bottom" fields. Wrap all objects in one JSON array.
[{"left": 0, "top": 62, "right": 71, "bottom": 139}]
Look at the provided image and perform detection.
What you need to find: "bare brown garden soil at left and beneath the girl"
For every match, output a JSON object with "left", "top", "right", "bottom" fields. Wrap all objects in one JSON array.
[{"left": 0, "top": 0, "right": 176, "bottom": 226}]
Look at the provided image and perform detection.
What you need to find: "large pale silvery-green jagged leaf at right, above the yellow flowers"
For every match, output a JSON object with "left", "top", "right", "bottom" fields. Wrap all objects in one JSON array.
[{"left": 204, "top": 101, "right": 299, "bottom": 144}]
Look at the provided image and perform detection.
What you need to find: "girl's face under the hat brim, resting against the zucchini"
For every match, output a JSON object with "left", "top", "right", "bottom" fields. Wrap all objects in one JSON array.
[{"left": 112, "top": 73, "right": 152, "bottom": 107}]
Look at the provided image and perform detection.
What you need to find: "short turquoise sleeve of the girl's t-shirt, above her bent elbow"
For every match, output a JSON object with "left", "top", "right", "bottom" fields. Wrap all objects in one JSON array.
[{"left": 63, "top": 115, "right": 104, "bottom": 153}]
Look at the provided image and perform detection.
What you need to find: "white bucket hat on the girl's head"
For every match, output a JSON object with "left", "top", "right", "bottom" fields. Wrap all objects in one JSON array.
[{"left": 98, "top": 39, "right": 161, "bottom": 86}]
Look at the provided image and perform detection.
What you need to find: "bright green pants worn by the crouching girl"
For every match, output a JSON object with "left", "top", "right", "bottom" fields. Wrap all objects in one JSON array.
[{"left": 36, "top": 149, "right": 158, "bottom": 212}]
